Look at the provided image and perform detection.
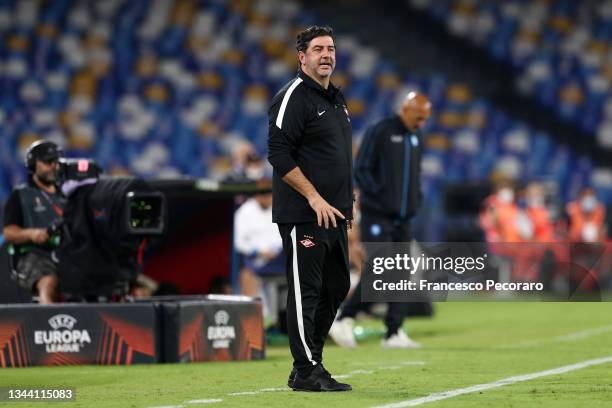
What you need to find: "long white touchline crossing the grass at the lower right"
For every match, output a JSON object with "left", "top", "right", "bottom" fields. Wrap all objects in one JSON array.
[{"left": 375, "top": 356, "right": 612, "bottom": 408}]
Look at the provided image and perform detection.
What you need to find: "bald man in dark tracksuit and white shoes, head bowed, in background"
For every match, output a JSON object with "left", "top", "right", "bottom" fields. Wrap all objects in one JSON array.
[{"left": 330, "top": 92, "right": 431, "bottom": 348}]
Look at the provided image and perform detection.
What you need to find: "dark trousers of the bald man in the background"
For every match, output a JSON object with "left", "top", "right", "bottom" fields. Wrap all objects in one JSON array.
[{"left": 340, "top": 211, "right": 412, "bottom": 337}]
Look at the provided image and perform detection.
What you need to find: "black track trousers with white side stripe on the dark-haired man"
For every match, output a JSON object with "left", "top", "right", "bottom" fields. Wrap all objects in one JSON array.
[{"left": 278, "top": 223, "right": 350, "bottom": 376}]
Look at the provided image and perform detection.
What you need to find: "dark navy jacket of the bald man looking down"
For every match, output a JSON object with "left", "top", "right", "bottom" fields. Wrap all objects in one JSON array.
[{"left": 355, "top": 115, "right": 422, "bottom": 219}]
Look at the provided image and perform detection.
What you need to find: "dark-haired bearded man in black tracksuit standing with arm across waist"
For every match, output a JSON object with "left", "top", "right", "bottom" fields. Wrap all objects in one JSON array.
[{"left": 268, "top": 26, "right": 353, "bottom": 391}]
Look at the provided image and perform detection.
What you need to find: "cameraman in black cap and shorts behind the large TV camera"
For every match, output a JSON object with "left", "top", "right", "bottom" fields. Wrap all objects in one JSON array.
[{"left": 3, "top": 140, "right": 65, "bottom": 304}]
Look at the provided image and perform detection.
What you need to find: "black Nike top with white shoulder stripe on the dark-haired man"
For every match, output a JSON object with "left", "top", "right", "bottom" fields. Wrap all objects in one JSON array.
[{"left": 268, "top": 71, "right": 353, "bottom": 223}]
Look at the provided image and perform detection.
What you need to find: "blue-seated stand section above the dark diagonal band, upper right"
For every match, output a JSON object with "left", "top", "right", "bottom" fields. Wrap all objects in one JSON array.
[{"left": 409, "top": 0, "right": 612, "bottom": 147}]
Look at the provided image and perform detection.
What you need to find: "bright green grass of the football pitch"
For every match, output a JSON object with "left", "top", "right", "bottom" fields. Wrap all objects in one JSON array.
[{"left": 0, "top": 303, "right": 612, "bottom": 408}]
